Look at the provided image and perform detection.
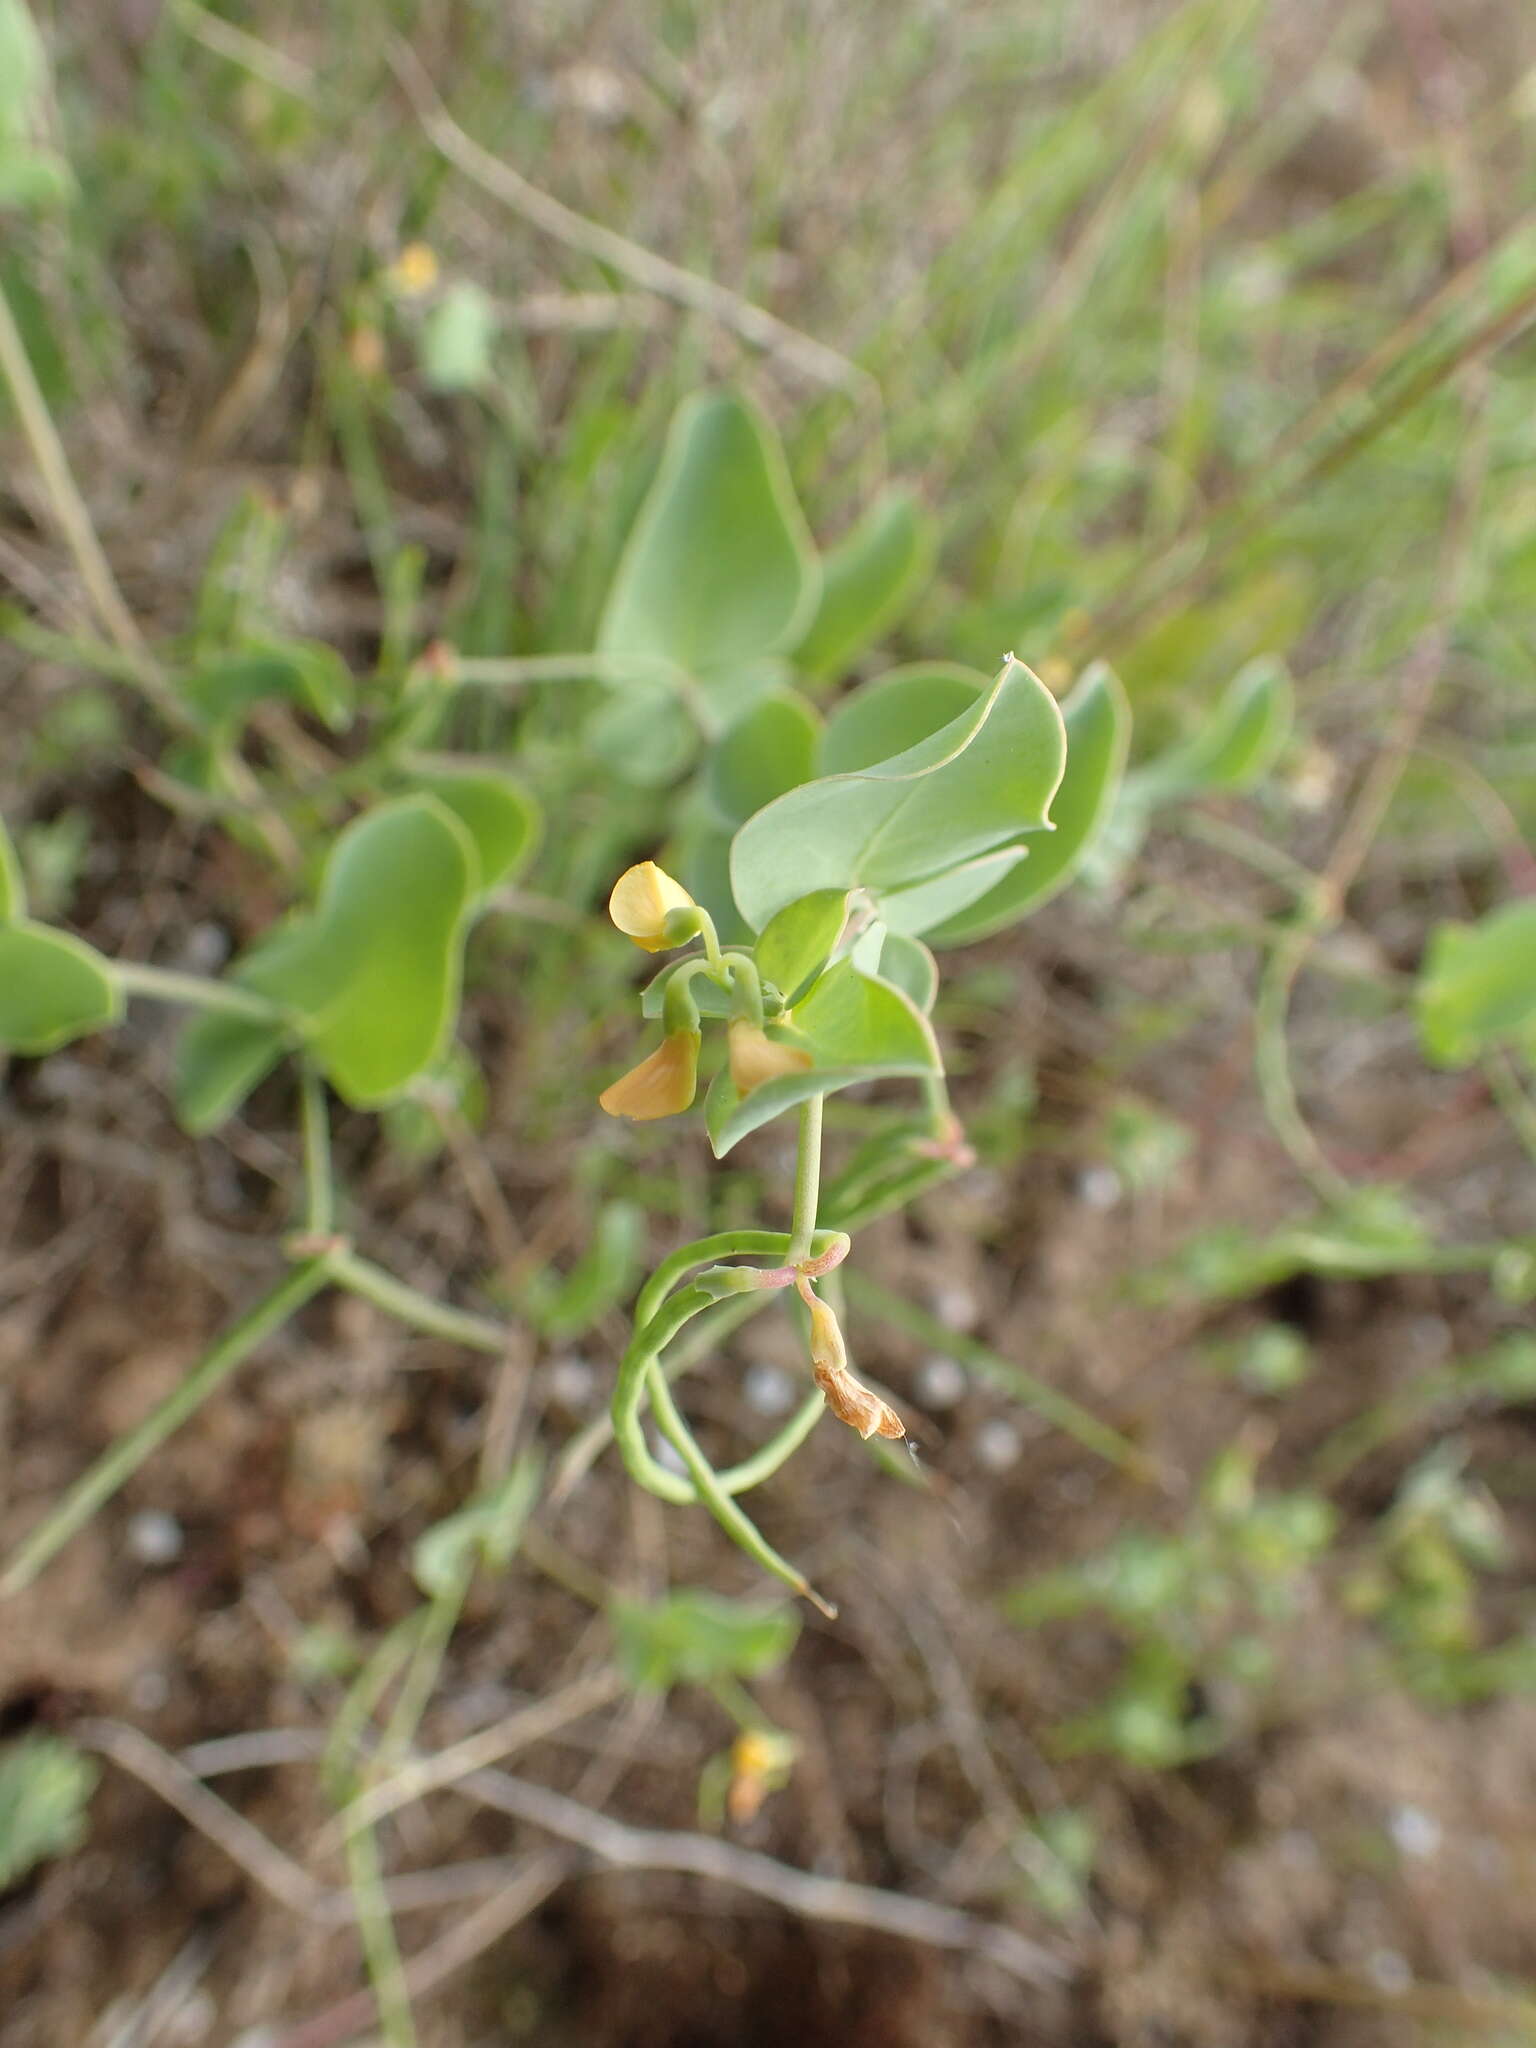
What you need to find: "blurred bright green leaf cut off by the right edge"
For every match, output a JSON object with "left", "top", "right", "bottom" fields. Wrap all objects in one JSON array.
[{"left": 1417, "top": 899, "right": 1536, "bottom": 1067}]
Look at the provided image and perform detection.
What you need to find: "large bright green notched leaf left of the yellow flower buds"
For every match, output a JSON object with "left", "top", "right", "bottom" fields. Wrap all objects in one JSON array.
[{"left": 236, "top": 797, "right": 477, "bottom": 1108}]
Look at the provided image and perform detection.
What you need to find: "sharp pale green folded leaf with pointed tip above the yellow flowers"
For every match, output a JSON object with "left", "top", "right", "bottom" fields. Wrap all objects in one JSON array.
[{"left": 731, "top": 655, "right": 1067, "bottom": 930}]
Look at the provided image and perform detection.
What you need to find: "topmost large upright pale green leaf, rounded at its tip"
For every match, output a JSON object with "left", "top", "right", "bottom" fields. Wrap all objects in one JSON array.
[{"left": 598, "top": 391, "right": 819, "bottom": 698}]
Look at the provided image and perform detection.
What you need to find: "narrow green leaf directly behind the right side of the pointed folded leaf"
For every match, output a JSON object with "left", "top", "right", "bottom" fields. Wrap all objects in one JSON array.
[{"left": 925, "top": 662, "right": 1130, "bottom": 946}]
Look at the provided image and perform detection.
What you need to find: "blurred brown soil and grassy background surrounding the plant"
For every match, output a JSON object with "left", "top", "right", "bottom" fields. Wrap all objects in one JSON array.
[{"left": 0, "top": 0, "right": 1536, "bottom": 2048}]
